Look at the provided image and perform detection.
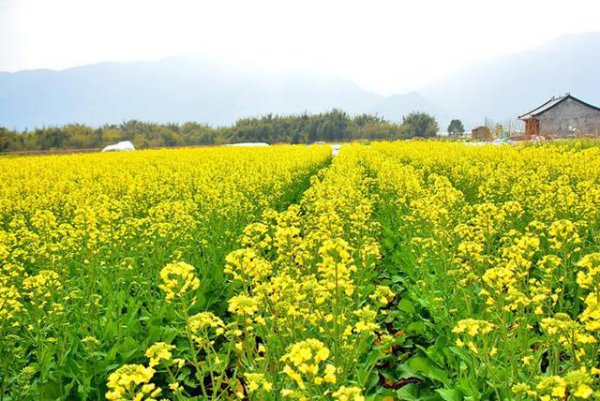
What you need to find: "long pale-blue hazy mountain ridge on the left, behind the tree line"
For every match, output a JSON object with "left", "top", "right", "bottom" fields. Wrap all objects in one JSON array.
[{"left": 0, "top": 58, "right": 435, "bottom": 129}]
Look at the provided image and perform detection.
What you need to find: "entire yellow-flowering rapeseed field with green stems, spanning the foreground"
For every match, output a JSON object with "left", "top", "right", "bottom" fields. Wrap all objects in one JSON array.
[{"left": 0, "top": 141, "right": 600, "bottom": 401}]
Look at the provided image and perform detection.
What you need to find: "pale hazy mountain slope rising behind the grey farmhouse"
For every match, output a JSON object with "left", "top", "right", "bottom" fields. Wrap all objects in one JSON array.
[{"left": 420, "top": 32, "right": 600, "bottom": 124}]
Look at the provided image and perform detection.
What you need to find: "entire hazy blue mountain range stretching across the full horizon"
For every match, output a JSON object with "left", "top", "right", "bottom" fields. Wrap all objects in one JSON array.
[{"left": 0, "top": 32, "right": 600, "bottom": 131}]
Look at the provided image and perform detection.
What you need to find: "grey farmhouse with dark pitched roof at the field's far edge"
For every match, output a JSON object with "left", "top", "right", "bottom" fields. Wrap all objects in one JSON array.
[{"left": 519, "top": 93, "right": 600, "bottom": 138}]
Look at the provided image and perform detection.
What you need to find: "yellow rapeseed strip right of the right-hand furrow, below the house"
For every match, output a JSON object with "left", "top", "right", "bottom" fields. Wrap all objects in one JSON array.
[{"left": 375, "top": 143, "right": 600, "bottom": 400}]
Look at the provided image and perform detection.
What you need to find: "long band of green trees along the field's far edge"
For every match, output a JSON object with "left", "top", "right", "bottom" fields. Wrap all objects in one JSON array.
[{"left": 0, "top": 109, "right": 438, "bottom": 152}]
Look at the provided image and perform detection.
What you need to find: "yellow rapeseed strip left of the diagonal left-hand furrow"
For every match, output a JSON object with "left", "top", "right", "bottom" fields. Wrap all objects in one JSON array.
[{"left": 0, "top": 147, "right": 329, "bottom": 400}]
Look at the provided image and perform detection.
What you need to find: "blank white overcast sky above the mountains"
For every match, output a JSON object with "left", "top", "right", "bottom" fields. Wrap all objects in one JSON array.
[{"left": 0, "top": 0, "right": 600, "bottom": 94}]
